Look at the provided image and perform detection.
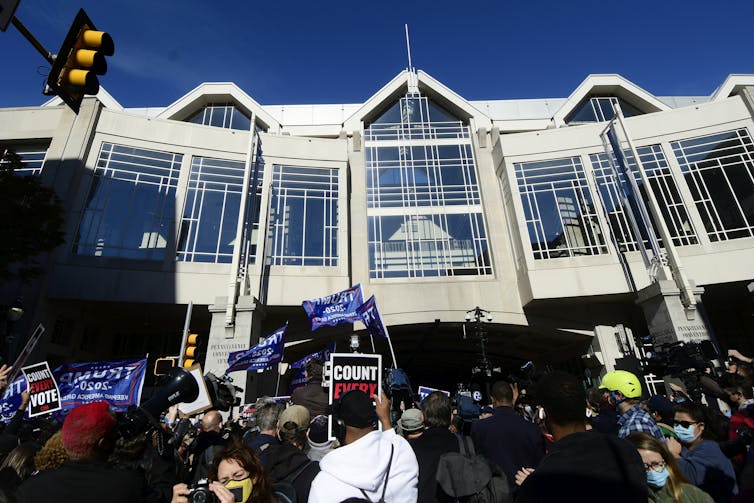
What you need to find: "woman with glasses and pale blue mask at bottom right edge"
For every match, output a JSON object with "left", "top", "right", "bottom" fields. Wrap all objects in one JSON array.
[{"left": 627, "top": 433, "right": 713, "bottom": 503}]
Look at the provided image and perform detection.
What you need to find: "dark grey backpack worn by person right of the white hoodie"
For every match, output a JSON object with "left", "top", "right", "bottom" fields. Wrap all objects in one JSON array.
[{"left": 435, "top": 436, "right": 513, "bottom": 503}]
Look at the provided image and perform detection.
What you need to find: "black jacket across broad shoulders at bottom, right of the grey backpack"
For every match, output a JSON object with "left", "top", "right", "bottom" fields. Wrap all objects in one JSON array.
[{"left": 516, "top": 431, "right": 647, "bottom": 503}]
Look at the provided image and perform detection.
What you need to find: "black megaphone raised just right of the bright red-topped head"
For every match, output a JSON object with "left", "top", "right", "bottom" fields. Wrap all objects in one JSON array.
[{"left": 117, "top": 367, "right": 199, "bottom": 438}]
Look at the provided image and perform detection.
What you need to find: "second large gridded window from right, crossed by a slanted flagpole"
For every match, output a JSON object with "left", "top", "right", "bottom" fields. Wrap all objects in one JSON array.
[{"left": 589, "top": 145, "right": 698, "bottom": 251}]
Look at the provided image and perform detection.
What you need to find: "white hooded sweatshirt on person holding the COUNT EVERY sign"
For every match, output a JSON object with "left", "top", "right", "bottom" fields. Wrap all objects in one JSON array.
[{"left": 309, "top": 429, "right": 419, "bottom": 503}]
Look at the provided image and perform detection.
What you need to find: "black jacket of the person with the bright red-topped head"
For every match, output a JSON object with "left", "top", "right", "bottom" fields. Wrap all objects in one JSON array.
[{"left": 17, "top": 460, "right": 154, "bottom": 503}]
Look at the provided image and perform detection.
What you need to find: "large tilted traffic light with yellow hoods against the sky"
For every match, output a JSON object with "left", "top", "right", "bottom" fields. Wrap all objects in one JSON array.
[{"left": 47, "top": 9, "right": 115, "bottom": 113}]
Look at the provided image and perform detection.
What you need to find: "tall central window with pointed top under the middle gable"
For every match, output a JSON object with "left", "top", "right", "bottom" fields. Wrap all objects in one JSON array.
[{"left": 364, "top": 94, "right": 492, "bottom": 278}]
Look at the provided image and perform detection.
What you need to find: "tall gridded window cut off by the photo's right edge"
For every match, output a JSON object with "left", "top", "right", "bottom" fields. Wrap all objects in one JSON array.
[{"left": 671, "top": 129, "right": 754, "bottom": 241}]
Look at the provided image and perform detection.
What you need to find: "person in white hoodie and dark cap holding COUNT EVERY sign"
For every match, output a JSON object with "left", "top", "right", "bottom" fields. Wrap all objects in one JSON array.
[{"left": 309, "top": 389, "right": 419, "bottom": 503}]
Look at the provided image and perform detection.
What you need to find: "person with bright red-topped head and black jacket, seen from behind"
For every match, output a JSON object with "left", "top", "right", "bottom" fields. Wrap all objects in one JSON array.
[{"left": 17, "top": 402, "right": 148, "bottom": 503}]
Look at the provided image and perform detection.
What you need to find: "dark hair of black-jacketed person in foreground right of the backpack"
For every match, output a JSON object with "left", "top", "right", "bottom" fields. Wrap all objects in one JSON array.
[{"left": 536, "top": 371, "right": 586, "bottom": 425}]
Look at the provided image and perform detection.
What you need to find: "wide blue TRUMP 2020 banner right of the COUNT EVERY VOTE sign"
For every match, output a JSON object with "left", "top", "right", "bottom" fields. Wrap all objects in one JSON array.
[{"left": 53, "top": 358, "right": 147, "bottom": 412}]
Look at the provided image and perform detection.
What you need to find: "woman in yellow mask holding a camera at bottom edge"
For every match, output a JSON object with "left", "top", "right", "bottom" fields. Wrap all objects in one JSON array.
[{"left": 171, "top": 444, "right": 277, "bottom": 503}]
